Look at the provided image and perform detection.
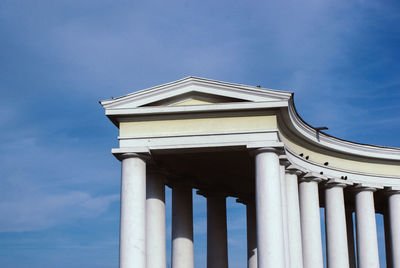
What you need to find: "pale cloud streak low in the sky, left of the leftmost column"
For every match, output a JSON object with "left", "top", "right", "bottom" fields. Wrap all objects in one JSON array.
[{"left": 0, "top": 192, "right": 119, "bottom": 232}]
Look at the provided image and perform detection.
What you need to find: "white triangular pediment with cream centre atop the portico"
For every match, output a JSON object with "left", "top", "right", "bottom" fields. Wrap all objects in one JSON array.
[{"left": 101, "top": 77, "right": 291, "bottom": 109}]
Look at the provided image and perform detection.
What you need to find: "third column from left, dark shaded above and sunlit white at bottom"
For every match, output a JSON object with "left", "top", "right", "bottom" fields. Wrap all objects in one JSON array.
[{"left": 172, "top": 185, "right": 194, "bottom": 268}]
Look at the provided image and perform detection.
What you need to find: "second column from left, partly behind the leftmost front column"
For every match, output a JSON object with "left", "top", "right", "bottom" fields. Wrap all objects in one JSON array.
[{"left": 146, "top": 171, "right": 167, "bottom": 268}]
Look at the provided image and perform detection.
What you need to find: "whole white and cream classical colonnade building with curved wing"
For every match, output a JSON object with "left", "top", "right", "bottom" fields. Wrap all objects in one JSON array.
[{"left": 101, "top": 77, "right": 400, "bottom": 268}]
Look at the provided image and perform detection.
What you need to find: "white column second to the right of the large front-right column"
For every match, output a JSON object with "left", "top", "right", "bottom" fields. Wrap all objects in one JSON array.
[{"left": 286, "top": 171, "right": 303, "bottom": 268}]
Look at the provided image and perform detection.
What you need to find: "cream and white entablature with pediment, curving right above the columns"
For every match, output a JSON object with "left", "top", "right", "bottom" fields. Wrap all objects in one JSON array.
[{"left": 101, "top": 77, "right": 400, "bottom": 187}]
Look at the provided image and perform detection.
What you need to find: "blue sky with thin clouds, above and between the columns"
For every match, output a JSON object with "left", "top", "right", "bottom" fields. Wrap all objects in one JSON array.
[{"left": 0, "top": 0, "right": 400, "bottom": 268}]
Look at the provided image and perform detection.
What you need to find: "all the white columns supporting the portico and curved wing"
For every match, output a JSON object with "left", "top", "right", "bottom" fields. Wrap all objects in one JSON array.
[{"left": 120, "top": 151, "right": 400, "bottom": 268}]
